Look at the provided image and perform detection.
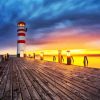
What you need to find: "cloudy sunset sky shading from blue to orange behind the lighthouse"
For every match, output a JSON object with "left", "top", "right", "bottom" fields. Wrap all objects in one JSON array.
[{"left": 0, "top": 0, "right": 100, "bottom": 53}]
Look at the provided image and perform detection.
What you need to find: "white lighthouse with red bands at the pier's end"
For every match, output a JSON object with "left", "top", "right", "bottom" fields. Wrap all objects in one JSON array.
[{"left": 17, "top": 22, "right": 27, "bottom": 57}]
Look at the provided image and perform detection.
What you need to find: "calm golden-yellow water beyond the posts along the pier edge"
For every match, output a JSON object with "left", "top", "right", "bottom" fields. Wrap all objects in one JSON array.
[{"left": 36, "top": 55, "right": 100, "bottom": 68}]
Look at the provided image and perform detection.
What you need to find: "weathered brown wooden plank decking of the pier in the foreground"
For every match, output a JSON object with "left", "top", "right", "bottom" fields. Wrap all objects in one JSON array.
[{"left": 0, "top": 58, "right": 100, "bottom": 100}]
